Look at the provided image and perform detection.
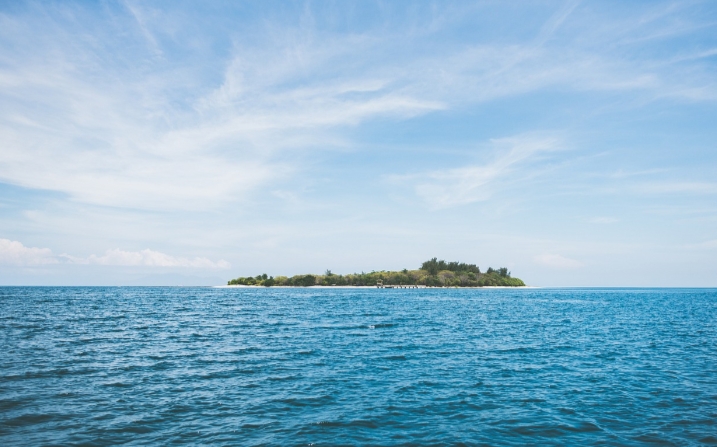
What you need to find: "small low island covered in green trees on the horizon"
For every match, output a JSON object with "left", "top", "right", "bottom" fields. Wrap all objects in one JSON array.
[{"left": 227, "top": 258, "right": 525, "bottom": 288}]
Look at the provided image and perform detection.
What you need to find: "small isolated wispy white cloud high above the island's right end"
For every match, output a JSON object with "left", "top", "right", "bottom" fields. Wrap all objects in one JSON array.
[{"left": 408, "top": 136, "right": 559, "bottom": 208}]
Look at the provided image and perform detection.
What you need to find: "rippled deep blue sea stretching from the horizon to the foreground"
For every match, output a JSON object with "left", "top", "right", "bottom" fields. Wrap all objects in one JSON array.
[{"left": 0, "top": 287, "right": 717, "bottom": 446}]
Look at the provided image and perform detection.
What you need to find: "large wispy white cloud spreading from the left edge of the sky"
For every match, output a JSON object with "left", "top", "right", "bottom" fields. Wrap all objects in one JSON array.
[{"left": 0, "top": 9, "right": 444, "bottom": 209}]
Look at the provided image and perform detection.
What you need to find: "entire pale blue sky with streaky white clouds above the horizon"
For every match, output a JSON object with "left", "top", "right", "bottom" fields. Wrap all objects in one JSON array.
[{"left": 0, "top": 0, "right": 717, "bottom": 287}]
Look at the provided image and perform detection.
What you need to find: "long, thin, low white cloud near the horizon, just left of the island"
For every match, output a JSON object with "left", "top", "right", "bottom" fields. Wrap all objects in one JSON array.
[{"left": 63, "top": 248, "right": 231, "bottom": 269}]
